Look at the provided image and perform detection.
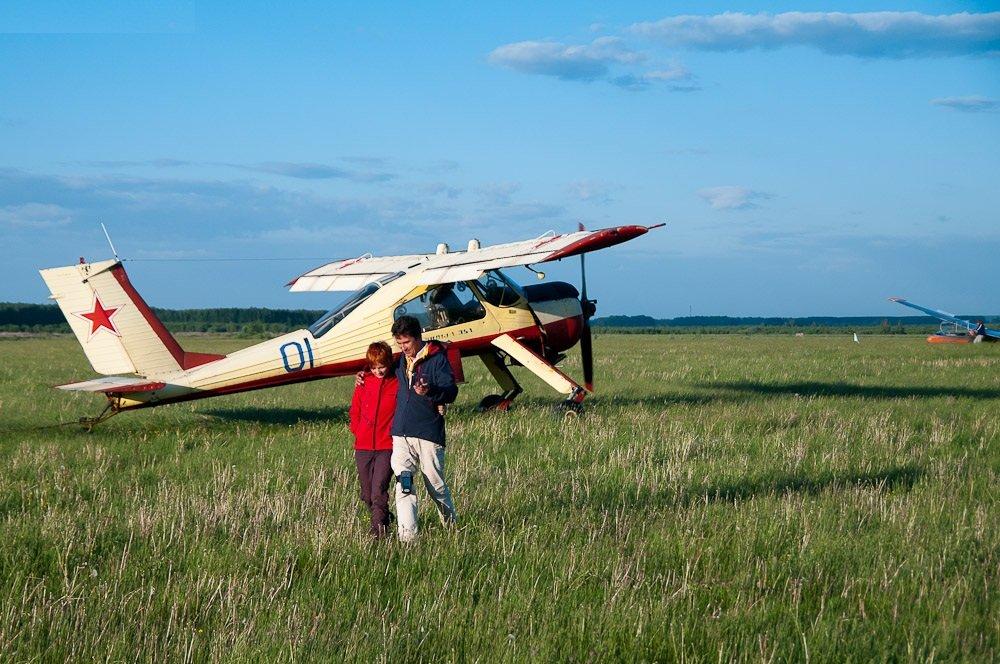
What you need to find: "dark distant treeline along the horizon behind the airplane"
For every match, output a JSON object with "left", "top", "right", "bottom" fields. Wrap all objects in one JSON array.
[{"left": 0, "top": 302, "right": 997, "bottom": 336}]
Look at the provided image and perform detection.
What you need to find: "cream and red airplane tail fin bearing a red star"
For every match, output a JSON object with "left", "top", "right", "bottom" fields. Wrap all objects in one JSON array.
[{"left": 40, "top": 259, "right": 225, "bottom": 376}]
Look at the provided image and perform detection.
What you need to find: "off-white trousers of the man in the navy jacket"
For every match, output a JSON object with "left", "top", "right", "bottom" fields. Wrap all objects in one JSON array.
[{"left": 391, "top": 436, "right": 455, "bottom": 542}]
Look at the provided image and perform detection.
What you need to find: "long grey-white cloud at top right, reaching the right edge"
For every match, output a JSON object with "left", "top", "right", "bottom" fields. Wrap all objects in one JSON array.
[{"left": 629, "top": 12, "right": 1000, "bottom": 58}]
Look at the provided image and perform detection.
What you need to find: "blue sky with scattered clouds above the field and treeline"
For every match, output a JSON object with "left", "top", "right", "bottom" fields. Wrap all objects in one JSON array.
[{"left": 0, "top": 0, "right": 1000, "bottom": 316}]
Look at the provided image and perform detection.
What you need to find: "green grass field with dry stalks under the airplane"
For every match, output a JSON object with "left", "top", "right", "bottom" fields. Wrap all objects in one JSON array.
[{"left": 0, "top": 335, "right": 1000, "bottom": 662}]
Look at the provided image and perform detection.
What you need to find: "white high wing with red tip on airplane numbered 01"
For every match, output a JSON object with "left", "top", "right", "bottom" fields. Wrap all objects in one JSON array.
[{"left": 289, "top": 224, "right": 663, "bottom": 291}]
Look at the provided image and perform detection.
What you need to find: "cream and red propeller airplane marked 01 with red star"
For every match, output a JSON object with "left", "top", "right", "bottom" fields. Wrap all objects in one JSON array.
[{"left": 40, "top": 224, "right": 664, "bottom": 428}]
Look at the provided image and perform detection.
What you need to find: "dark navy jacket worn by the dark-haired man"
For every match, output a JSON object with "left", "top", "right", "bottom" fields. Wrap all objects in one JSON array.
[{"left": 392, "top": 341, "right": 458, "bottom": 445}]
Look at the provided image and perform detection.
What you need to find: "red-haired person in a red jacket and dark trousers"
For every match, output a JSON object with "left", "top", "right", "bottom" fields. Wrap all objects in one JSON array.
[{"left": 351, "top": 341, "right": 399, "bottom": 537}]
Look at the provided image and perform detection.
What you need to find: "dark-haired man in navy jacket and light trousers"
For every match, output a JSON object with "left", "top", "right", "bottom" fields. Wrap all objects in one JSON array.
[{"left": 391, "top": 316, "right": 458, "bottom": 542}]
